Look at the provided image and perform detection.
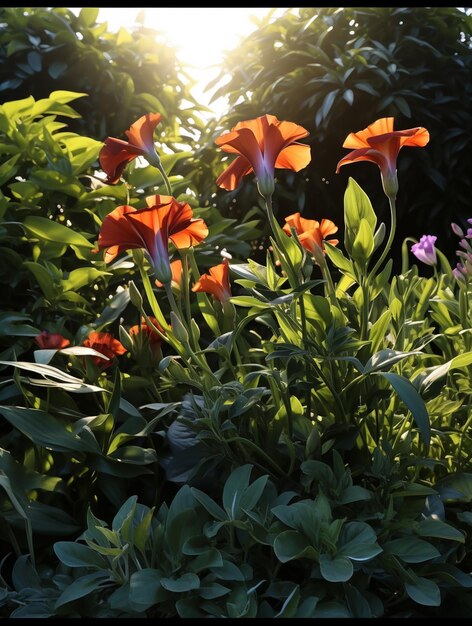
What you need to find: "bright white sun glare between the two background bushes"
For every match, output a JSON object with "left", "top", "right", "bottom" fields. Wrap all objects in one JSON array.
[{"left": 92, "top": 7, "right": 287, "bottom": 114}]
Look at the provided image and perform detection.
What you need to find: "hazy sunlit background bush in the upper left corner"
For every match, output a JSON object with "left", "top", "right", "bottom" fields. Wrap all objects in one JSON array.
[{"left": 0, "top": 7, "right": 202, "bottom": 146}]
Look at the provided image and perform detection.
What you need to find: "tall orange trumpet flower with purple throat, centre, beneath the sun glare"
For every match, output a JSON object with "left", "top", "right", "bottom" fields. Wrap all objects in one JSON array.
[{"left": 215, "top": 115, "right": 311, "bottom": 196}]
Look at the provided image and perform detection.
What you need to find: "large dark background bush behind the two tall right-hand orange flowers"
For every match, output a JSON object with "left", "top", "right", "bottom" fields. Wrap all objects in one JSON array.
[{"left": 195, "top": 7, "right": 472, "bottom": 261}]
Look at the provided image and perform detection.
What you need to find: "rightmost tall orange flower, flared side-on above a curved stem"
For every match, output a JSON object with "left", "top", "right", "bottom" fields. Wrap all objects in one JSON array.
[{"left": 336, "top": 117, "right": 429, "bottom": 197}]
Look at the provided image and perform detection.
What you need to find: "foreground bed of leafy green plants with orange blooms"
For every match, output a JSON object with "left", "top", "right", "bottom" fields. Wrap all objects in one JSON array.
[{"left": 0, "top": 90, "right": 472, "bottom": 618}]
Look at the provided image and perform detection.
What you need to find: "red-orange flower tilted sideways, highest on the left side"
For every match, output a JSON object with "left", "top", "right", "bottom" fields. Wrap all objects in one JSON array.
[{"left": 98, "top": 113, "right": 161, "bottom": 185}]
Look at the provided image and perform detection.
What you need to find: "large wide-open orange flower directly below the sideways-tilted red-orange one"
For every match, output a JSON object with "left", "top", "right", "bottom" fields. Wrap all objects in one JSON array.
[{"left": 98, "top": 195, "right": 208, "bottom": 283}]
